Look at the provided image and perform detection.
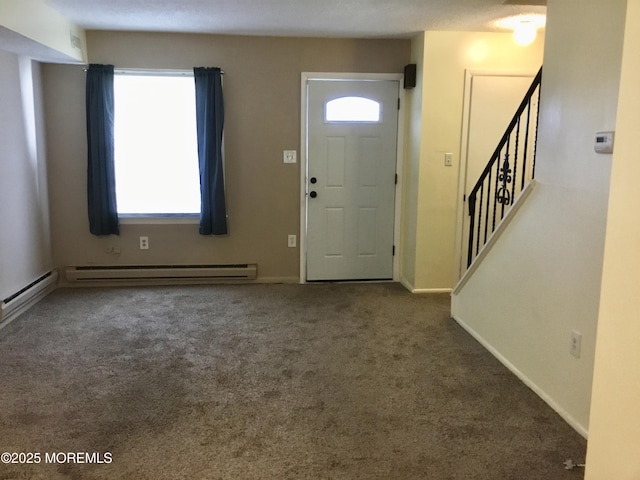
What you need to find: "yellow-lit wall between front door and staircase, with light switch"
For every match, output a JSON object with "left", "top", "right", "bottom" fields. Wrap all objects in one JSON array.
[{"left": 403, "top": 32, "right": 544, "bottom": 292}]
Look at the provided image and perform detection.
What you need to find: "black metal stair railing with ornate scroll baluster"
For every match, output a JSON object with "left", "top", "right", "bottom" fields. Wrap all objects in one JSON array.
[{"left": 467, "top": 68, "right": 542, "bottom": 267}]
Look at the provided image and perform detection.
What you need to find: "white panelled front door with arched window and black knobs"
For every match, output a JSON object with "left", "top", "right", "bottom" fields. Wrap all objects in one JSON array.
[{"left": 306, "top": 80, "right": 400, "bottom": 281}]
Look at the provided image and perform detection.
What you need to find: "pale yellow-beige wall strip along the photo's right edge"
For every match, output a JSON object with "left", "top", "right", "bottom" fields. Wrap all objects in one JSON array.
[{"left": 585, "top": 1, "right": 640, "bottom": 480}]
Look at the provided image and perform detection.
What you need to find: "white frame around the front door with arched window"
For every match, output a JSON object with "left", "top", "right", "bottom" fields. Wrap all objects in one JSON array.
[{"left": 298, "top": 72, "right": 405, "bottom": 284}]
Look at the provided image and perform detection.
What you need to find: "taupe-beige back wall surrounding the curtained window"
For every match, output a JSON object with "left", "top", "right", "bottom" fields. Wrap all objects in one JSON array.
[{"left": 43, "top": 32, "right": 410, "bottom": 282}]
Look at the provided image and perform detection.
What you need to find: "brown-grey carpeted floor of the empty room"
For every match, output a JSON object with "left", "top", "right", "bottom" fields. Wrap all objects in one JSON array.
[{"left": 0, "top": 284, "right": 586, "bottom": 480}]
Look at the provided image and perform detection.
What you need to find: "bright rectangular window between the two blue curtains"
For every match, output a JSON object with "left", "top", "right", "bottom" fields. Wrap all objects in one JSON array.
[{"left": 114, "top": 71, "right": 200, "bottom": 217}]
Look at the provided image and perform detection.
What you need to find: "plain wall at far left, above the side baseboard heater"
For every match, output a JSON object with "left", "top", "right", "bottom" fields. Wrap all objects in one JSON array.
[{"left": 0, "top": 50, "right": 53, "bottom": 300}]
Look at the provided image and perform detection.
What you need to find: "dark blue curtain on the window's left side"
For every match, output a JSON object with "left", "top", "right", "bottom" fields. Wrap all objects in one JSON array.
[{"left": 86, "top": 65, "right": 120, "bottom": 235}]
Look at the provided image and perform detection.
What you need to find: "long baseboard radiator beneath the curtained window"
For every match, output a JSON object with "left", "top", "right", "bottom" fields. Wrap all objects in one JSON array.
[{"left": 65, "top": 263, "right": 258, "bottom": 285}]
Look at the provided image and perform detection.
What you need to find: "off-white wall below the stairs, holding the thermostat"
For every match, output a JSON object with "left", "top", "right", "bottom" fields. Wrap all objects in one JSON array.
[{"left": 452, "top": 0, "right": 626, "bottom": 436}]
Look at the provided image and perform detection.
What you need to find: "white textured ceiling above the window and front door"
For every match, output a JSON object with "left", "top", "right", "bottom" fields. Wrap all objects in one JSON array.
[{"left": 45, "top": 0, "right": 545, "bottom": 38}]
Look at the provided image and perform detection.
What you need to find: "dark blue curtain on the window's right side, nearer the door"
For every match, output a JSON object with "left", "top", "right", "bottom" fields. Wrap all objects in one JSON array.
[{"left": 193, "top": 67, "right": 227, "bottom": 235}]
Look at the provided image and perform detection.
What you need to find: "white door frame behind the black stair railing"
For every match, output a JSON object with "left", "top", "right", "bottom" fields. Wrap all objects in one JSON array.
[{"left": 453, "top": 68, "right": 537, "bottom": 284}]
